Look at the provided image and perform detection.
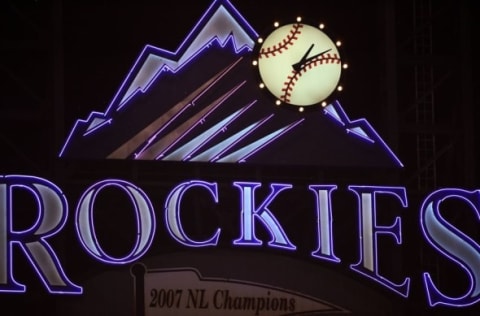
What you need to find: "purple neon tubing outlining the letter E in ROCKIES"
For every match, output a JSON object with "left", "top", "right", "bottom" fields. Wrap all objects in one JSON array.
[{"left": 348, "top": 185, "right": 410, "bottom": 298}]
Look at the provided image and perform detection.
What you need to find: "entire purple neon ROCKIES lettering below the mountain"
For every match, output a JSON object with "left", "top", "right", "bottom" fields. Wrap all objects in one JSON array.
[{"left": 0, "top": 175, "right": 480, "bottom": 307}]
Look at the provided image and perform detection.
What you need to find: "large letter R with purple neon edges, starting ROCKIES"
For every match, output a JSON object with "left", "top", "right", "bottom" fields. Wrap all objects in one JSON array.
[{"left": 0, "top": 175, "right": 82, "bottom": 294}]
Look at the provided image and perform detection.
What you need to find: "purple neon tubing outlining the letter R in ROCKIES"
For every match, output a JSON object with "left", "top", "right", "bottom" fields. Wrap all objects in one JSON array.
[{"left": 0, "top": 174, "right": 83, "bottom": 295}]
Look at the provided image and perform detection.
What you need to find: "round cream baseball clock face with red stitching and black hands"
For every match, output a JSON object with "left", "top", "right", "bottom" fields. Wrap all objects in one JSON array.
[{"left": 257, "top": 23, "right": 342, "bottom": 107}]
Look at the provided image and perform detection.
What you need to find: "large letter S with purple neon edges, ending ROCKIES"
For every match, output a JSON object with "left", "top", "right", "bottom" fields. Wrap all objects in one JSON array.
[{"left": 420, "top": 189, "right": 480, "bottom": 307}]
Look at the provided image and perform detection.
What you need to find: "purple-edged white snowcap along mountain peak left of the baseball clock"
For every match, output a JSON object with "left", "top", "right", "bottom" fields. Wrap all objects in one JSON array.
[{"left": 59, "top": 0, "right": 258, "bottom": 157}]
